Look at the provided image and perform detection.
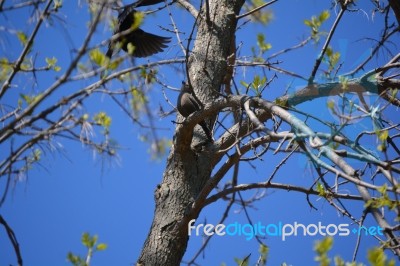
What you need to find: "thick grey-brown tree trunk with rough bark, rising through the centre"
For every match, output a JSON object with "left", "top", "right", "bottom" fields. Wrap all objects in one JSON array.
[{"left": 138, "top": 0, "right": 244, "bottom": 266}]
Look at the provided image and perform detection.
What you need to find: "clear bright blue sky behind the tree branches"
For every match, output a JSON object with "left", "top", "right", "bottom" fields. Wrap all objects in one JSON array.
[{"left": 0, "top": 0, "right": 399, "bottom": 265}]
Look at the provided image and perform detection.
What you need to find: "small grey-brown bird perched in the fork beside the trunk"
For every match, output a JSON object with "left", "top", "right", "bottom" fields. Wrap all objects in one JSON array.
[{"left": 176, "top": 83, "right": 213, "bottom": 142}]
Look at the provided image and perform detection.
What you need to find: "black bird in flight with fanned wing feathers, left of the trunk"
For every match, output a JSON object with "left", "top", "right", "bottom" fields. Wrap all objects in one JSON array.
[{"left": 106, "top": 0, "right": 171, "bottom": 58}]
